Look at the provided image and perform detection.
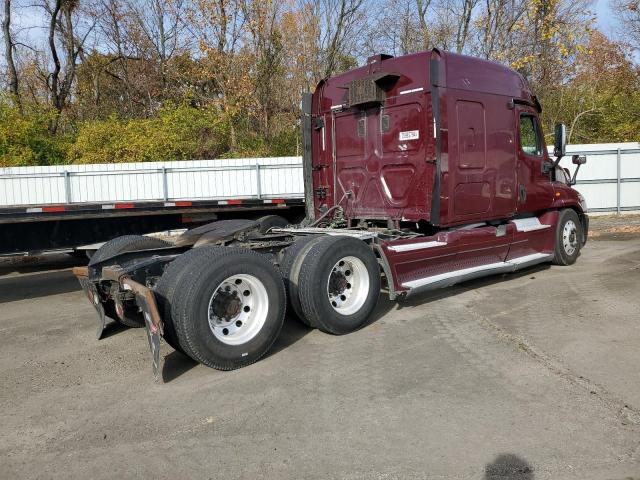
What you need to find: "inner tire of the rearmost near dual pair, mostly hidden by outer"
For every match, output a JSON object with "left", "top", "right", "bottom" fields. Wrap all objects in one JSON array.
[{"left": 154, "top": 245, "right": 223, "bottom": 355}]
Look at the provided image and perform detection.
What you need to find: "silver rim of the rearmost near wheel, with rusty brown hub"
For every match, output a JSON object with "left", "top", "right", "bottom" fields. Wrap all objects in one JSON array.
[{"left": 207, "top": 274, "right": 269, "bottom": 345}]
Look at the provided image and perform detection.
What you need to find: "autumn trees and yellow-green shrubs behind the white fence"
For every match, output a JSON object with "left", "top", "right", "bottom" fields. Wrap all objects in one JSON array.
[{"left": 0, "top": 0, "right": 640, "bottom": 166}]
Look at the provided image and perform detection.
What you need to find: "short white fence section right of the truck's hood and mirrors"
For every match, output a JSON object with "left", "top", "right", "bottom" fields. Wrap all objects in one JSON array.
[{"left": 550, "top": 143, "right": 640, "bottom": 213}]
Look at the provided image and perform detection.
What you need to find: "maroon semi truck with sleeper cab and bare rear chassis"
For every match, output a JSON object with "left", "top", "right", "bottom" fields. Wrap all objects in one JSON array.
[{"left": 75, "top": 50, "right": 588, "bottom": 378}]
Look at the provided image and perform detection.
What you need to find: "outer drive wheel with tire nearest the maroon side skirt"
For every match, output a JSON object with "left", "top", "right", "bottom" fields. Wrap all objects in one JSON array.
[{"left": 298, "top": 236, "right": 380, "bottom": 335}]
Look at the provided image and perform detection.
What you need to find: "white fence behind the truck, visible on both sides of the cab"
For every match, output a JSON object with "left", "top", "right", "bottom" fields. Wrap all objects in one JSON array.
[{"left": 0, "top": 143, "right": 640, "bottom": 212}]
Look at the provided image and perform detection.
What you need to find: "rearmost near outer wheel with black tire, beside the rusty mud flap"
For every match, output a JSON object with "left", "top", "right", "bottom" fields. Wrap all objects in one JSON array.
[{"left": 171, "top": 247, "right": 286, "bottom": 370}]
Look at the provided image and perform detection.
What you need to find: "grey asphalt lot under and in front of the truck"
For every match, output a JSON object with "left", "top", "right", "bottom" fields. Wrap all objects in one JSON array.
[{"left": 0, "top": 222, "right": 640, "bottom": 480}]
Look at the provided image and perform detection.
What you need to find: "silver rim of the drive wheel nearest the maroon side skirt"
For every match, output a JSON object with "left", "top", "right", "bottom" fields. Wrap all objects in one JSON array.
[{"left": 327, "top": 256, "right": 370, "bottom": 315}]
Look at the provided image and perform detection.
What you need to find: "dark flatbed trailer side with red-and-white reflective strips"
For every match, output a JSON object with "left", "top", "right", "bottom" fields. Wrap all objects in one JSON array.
[{"left": 0, "top": 198, "right": 304, "bottom": 255}]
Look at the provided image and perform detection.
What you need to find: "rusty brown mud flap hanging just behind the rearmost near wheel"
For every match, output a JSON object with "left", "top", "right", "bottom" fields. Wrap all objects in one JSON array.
[{"left": 122, "top": 278, "right": 164, "bottom": 383}]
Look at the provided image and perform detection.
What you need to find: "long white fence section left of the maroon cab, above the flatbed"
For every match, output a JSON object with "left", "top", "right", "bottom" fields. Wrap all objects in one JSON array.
[{"left": 0, "top": 157, "right": 304, "bottom": 206}]
